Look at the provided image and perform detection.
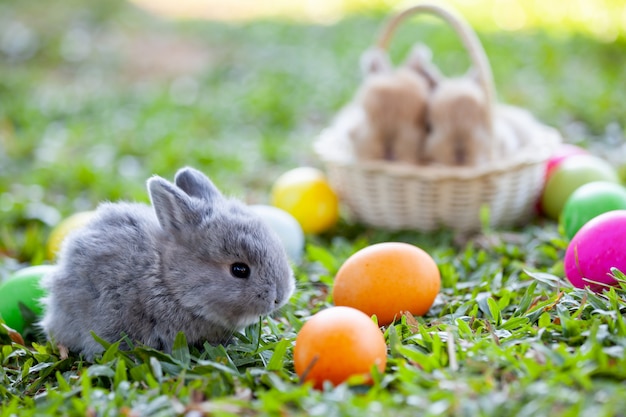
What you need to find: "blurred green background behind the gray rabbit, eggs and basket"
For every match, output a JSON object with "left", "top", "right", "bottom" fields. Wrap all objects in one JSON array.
[{"left": 0, "top": 0, "right": 626, "bottom": 264}]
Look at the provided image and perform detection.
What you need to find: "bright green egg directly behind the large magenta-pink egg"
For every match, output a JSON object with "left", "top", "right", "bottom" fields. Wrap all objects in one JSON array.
[{"left": 561, "top": 181, "right": 626, "bottom": 239}]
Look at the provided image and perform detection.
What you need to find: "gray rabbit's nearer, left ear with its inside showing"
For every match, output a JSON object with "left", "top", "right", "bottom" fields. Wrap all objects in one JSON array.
[{"left": 148, "top": 176, "right": 201, "bottom": 231}]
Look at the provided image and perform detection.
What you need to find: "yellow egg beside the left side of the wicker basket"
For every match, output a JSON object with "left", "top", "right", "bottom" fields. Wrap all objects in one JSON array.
[{"left": 272, "top": 167, "right": 339, "bottom": 234}]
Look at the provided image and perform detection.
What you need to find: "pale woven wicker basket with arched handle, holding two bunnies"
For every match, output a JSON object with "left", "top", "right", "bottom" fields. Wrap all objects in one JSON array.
[{"left": 314, "top": 4, "right": 561, "bottom": 231}]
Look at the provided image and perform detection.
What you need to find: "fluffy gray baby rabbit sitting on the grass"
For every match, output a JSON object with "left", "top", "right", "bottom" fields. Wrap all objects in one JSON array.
[{"left": 40, "top": 168, "right": 295, "bottom": 359}]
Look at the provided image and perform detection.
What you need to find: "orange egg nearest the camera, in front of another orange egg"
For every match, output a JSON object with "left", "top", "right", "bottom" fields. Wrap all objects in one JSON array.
[{"left": 293, "top": 307, "right": 387, "bottom": 389}]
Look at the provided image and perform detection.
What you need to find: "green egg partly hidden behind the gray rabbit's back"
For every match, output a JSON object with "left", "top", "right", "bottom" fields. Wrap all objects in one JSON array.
[{"left": 0, "top": 265, "right": 54, "bottom": 332}]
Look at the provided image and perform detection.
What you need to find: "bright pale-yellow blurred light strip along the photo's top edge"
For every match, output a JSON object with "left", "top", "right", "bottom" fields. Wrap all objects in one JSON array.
[{"left": 131, "top": 0, "right": 626, "bottom": 42}]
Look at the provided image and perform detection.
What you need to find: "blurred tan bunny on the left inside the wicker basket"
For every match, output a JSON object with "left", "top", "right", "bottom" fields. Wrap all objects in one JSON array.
[{"left": 350, "top": 49, "right": 430, "bottom": 164}]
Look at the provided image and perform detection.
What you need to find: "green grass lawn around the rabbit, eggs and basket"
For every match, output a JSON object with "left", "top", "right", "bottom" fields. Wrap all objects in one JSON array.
[{"left": 0, "top": 0, "right": 626, "bottom": 416}]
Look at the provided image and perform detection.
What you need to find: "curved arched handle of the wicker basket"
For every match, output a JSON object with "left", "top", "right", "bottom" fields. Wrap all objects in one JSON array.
[{"left": 376, "top": 3, "right": 495, "bottom": 133}]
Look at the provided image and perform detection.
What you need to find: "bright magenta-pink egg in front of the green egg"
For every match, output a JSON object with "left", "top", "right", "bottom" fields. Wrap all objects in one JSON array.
[{"left": 565, "top": 210, "right": 626, "bottom": 292}]
